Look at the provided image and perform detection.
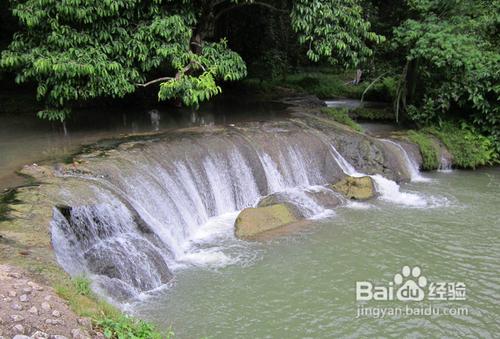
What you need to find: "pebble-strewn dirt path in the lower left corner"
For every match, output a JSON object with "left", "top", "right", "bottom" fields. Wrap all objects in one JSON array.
[{"left": 0, "top": 265, "right": 104, "bottom": 339}]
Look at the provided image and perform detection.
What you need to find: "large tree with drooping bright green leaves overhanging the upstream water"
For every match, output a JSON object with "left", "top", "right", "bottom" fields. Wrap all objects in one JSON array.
[{"left": 0, "top": 0, "right": 382, "bottom": 121}]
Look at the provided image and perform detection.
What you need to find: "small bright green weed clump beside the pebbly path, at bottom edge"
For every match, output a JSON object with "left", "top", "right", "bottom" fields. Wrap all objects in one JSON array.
[{"left": 96, "top": 316, "right": 174, "bottom": 339}]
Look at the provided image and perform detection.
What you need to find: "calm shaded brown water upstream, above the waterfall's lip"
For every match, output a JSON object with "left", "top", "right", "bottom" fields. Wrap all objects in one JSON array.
[{"left": 0, "top": 97, "right": 285, "bottom": 190}]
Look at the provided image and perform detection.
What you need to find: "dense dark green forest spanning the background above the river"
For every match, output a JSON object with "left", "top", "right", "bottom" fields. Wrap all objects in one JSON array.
[{"left": 0, "top": 0, "right": 500, "bottom": 167}]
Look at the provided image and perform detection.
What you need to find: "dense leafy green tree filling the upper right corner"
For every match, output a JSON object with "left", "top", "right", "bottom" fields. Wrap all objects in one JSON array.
[{"left": 392, "top": 0, "right": 500, "bottom": 151}]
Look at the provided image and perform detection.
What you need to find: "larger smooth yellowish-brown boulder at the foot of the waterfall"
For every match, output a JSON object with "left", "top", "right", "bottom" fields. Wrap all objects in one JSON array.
[{"left": 234, "top": 204, "right": 299, "bottom": 239}]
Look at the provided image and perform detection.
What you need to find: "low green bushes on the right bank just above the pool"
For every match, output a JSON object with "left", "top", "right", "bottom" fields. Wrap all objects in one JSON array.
[{"left": 425, "top": 122, "right": 499, "bottom": 168}]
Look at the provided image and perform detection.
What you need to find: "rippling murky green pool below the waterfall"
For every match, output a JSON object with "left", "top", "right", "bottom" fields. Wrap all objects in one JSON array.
[{"left": 130, "top": 168, "right": 500, "bottom": 338}]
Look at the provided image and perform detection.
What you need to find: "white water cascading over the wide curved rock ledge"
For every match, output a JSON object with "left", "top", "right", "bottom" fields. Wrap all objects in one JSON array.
[{"left": 52, "top": 122, "right": 442, "bottom": 300}]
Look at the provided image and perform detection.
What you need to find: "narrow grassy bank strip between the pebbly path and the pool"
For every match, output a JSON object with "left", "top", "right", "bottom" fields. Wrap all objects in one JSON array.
[{"left": 54, "top": 276, "right": 169, "bottom": 339}]
